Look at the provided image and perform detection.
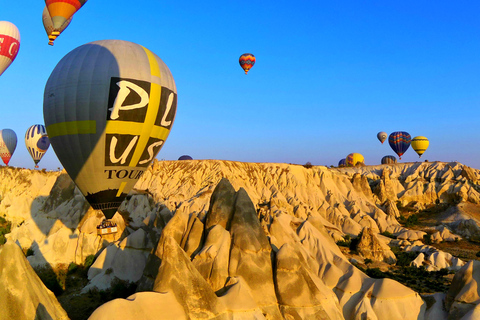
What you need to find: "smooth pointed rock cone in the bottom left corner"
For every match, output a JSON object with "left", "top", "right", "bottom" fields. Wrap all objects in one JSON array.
[{"left": 0, "top": 241, "right": 68, "bottom": 320}]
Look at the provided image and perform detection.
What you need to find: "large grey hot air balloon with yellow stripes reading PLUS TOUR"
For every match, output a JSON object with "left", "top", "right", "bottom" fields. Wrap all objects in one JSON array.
[{"left": 43, "top": 40, "right": 177, "bottom": 233}]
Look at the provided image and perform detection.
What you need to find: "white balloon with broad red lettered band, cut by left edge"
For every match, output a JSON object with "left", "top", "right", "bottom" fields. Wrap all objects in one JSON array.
[{"left": 0, "top": 21, "right": 20, "bottom": 75}]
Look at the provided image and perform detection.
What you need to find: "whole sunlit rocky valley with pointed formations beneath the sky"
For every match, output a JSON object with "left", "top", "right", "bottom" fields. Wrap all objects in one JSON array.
[{"left": 0, "top": 160, "right": 480, "bottom": 320}]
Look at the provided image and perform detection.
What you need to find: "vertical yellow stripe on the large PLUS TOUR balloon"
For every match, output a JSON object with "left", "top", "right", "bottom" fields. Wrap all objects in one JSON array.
[{"left": 130, "top": 47, "right": 163, "bottom": 167}]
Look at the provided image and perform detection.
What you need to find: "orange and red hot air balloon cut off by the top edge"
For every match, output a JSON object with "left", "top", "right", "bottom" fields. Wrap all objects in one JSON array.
[{"left": 45, "top": 0, "right": 87, "bottom": 37}]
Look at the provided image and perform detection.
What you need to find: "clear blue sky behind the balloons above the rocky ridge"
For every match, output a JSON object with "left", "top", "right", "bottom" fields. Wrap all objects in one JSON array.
[{"left": 0, "top": 0, "right": 480, "bottom": 169}]
